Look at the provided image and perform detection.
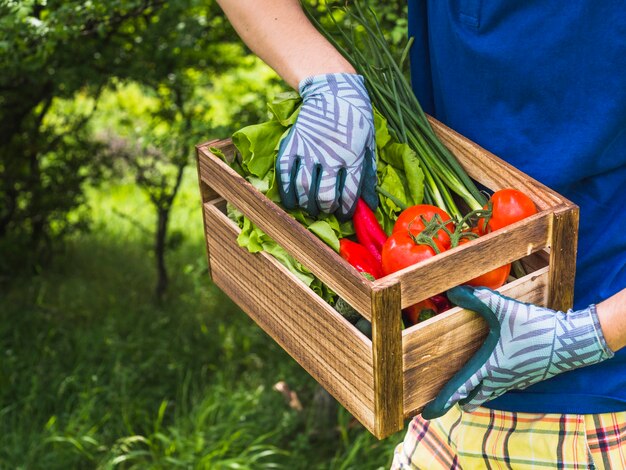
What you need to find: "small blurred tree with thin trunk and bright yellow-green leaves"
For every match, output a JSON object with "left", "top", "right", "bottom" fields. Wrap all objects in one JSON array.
[{"left": 93, "top": 60, "right": 280, "bottom": 300}]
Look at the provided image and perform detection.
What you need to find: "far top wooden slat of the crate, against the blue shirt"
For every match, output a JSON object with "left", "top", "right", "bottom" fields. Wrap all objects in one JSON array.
[{"left": 429, "top": 117, "right": 569, "bottom": 210}]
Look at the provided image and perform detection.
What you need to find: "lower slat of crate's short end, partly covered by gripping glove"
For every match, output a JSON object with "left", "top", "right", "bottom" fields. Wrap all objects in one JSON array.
[{"left": 402, "top": 267, "right": 549, "bottom": 417}]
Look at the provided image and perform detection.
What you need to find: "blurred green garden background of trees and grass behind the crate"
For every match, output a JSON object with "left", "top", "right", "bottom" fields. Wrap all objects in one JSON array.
[{"left": 0, "top": 0, "right": 406, "bottom": 469}]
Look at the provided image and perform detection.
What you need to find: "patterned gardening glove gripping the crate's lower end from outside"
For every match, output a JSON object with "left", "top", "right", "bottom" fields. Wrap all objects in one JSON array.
[{"left": 422, "top": 286, "right": 613, "bottom": 419}]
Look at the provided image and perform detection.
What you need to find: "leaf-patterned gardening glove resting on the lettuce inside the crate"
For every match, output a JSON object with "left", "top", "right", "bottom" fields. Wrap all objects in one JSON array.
[{"left": 276, "top": 73, "right": 378, "bottom": 220}]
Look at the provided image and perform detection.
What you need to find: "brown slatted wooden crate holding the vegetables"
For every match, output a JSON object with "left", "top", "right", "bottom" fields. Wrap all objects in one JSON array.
[{"left": 197, "top": 116, "right": 578, "bottom": 438}]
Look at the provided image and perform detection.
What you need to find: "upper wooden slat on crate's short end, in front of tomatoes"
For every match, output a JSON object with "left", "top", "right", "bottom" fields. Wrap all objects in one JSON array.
[{"left": 374, "top": 212, "right": 552, "bottom": 308}]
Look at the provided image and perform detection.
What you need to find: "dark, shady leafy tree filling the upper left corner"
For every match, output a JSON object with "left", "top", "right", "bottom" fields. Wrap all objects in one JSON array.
[{"left": 0, "top": 0, "right": 236, "bottom": 264}]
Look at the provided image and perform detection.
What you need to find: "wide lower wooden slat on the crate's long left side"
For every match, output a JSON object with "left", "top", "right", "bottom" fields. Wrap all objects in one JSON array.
[{"left": 204, "top": 200, "right": 376, "bottom": 434}]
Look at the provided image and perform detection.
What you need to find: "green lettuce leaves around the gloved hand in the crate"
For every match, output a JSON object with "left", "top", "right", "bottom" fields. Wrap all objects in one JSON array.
[{"left": 228, "top": 92, "right": 424, "bottom": 304}]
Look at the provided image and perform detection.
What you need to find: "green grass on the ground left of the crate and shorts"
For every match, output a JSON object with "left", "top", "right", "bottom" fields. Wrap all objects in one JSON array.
[{"left": 0, "top": 168, "right": 401, "bottom": 469}]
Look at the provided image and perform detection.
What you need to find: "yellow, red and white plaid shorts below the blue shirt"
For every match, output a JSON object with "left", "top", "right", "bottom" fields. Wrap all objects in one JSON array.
[{"left": 391, "top": 406, "right": 626, "bottom": 470}]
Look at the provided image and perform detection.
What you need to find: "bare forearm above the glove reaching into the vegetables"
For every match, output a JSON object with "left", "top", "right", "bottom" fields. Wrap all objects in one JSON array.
[{"left": 217, "top": 0, "right": 354, "bottom": 88}]
